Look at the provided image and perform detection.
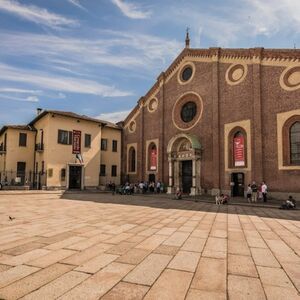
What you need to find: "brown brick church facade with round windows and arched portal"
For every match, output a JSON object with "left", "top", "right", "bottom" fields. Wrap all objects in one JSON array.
[{"left": 122, "top": 35, "right": 300, "bottom": 199}]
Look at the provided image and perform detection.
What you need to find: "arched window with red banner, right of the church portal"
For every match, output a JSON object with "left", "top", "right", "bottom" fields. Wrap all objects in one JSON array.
[{"left": 229, "top": 127, "right": 247, "bottom": 168}]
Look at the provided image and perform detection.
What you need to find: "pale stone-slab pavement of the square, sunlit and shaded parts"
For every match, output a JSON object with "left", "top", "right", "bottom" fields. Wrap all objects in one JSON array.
[{"left": 0, "top": 192, "right": 300, "bottom": 300}]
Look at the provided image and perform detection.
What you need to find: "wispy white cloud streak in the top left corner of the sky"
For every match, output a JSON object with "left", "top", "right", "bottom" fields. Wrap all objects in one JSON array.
[{"left": 0, "top": 0, "right": 78, "bottom": 28}]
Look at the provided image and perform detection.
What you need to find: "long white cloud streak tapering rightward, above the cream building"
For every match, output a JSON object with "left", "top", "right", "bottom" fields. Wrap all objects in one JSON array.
[{"left": 0, "top": 63, "right": 132, "bottom": 97}]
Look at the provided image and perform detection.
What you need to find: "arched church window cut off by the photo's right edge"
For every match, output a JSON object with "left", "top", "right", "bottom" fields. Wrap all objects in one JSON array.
[{"left": 282, "top": 115, "right": 300, "bottom": 166}]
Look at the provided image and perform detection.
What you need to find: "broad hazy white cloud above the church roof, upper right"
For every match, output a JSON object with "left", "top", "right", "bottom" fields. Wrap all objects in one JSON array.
[{"left": 165, "top": 0, "right": 300, "bottom": 47}]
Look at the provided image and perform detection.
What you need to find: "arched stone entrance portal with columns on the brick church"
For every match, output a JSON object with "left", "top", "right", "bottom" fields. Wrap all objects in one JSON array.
[{"left": 167, "top": 133, "right": 201, "bottom": 195}]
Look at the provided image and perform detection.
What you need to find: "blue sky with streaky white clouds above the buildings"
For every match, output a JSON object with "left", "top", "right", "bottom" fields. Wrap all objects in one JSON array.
[{"left": 0, "top": 0, "right": 300, "bottom": 126}]
